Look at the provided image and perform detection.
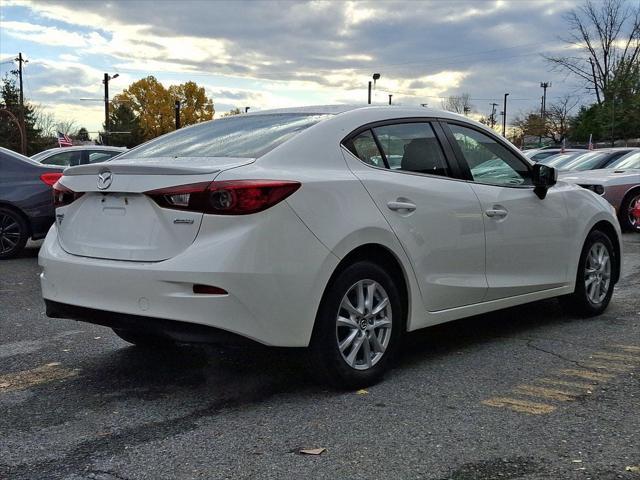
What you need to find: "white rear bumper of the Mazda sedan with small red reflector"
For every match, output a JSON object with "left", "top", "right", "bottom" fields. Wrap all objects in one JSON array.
[{"left": 39, "top": 204, "right": 338, "bottom": 347}]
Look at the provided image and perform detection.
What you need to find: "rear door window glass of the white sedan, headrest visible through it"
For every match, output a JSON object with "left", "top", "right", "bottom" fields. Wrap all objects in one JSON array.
[{"left": 373, "top": 123, "right": 449, "bottom": 175}]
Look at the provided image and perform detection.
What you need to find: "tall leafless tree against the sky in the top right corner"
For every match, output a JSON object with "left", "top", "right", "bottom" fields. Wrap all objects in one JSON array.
[{"left": 544, "top": 0, "right": 640, "bottom": 104}]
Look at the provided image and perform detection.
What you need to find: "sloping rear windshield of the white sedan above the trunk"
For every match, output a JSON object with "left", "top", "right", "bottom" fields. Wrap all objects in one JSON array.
[{"left": 118, "top": 113, "right": 331, "bottom": 160}]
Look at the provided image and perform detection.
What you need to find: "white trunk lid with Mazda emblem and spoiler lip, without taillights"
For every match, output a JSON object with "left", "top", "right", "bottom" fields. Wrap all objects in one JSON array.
[{"left": 56, "top": 158, "right": 254, "bottom": 262}]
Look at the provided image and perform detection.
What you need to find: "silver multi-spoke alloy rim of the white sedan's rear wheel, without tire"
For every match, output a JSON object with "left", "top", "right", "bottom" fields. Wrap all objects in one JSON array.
[{"left": 336, "top": 279, "right": 392, "bottom": 370}]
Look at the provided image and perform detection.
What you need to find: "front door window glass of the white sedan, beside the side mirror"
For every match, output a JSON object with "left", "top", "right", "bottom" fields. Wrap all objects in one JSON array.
[{"left": 449, "top": 124, "right": 531, "bottom": 186}]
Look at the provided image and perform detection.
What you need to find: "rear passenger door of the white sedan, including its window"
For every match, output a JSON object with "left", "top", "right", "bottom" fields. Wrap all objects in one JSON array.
[{"left": 345, "top": 121, "right": 487, "bottom": 312}]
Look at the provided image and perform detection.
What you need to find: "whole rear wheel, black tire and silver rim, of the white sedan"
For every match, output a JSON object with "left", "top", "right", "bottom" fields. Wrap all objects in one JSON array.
[{"left": 310, "top": 261, "right": 404, "bottom": 389}]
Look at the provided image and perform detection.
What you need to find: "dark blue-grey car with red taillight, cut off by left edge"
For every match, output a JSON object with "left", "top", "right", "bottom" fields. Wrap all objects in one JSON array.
[{"left": 0, "top": 147, "right": 63, "bottom": 260}]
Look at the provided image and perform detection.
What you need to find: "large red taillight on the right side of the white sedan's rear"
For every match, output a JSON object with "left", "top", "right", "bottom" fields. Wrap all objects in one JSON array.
[{"left": 145, "top": 180, "right": 300, "bottom": 215}]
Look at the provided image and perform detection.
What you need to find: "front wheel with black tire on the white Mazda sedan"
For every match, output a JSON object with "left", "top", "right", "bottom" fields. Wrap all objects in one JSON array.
[{"left": 560, "top": 230, "right": 617, "bottom": 317}]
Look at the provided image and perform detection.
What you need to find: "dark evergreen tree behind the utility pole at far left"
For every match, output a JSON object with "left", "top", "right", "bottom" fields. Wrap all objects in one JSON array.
[{"left": 0, "top": 74, "right": 42, "bottom": 155}]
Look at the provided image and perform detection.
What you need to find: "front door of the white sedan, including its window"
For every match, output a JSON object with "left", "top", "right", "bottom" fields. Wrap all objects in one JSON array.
[{"left": 445, "top": 122, "right": 573, "bottom": 301}]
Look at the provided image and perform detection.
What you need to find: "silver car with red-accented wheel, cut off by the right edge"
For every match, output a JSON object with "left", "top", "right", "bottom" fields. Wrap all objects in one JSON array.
[{"left": 560, "top": 150, "right": 640, "bottom": 232}]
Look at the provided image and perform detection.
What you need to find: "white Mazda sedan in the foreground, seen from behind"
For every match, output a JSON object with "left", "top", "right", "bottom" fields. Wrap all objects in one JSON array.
[{"left": 40, "top": 106, "right": 621, "bottom": 387}]
